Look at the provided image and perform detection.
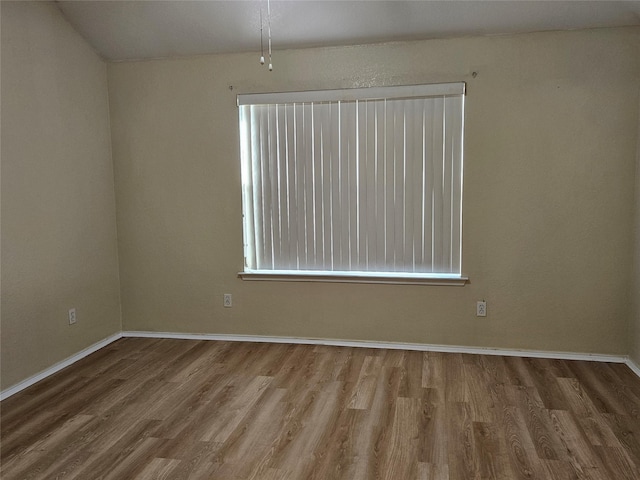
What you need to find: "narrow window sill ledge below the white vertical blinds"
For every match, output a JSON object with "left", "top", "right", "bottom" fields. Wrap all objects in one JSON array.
[{"left": 238, "top": 271, "right": 469, "bottom": 286}]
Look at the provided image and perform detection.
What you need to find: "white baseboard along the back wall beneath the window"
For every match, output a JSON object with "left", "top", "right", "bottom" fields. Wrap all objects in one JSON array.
[{"left": 122, "top": 331, "right": 640, "bottom": 366}]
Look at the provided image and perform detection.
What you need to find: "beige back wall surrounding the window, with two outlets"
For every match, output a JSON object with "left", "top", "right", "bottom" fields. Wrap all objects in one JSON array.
[{"left": 108, "top": 28, "right": 640, "bottom": 354}]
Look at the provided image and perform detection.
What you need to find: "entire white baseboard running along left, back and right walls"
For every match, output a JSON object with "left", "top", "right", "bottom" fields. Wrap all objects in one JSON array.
[{"left": 0, "top": 331, "right": 640, "bottom": 401}]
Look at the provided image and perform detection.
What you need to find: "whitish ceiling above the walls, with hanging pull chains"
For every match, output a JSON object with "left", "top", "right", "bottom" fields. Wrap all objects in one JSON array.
[{"left": 56, "top": 0, "right": 640, "bottom": 61}]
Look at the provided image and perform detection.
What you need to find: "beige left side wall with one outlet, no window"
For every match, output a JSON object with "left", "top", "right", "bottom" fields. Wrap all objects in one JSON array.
[{"left": 0, "top": 1, "right": 121, "bottom": 389}]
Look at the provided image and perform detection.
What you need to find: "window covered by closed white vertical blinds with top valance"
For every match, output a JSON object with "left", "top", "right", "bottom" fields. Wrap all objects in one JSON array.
[{"left": 238, "top": 83, "right": 465, "bottom": 283}]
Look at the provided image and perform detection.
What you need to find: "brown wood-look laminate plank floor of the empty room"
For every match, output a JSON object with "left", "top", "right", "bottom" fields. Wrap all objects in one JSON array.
[{"left": 0, "top": 338, "right": 640, "bottom": 480}]
